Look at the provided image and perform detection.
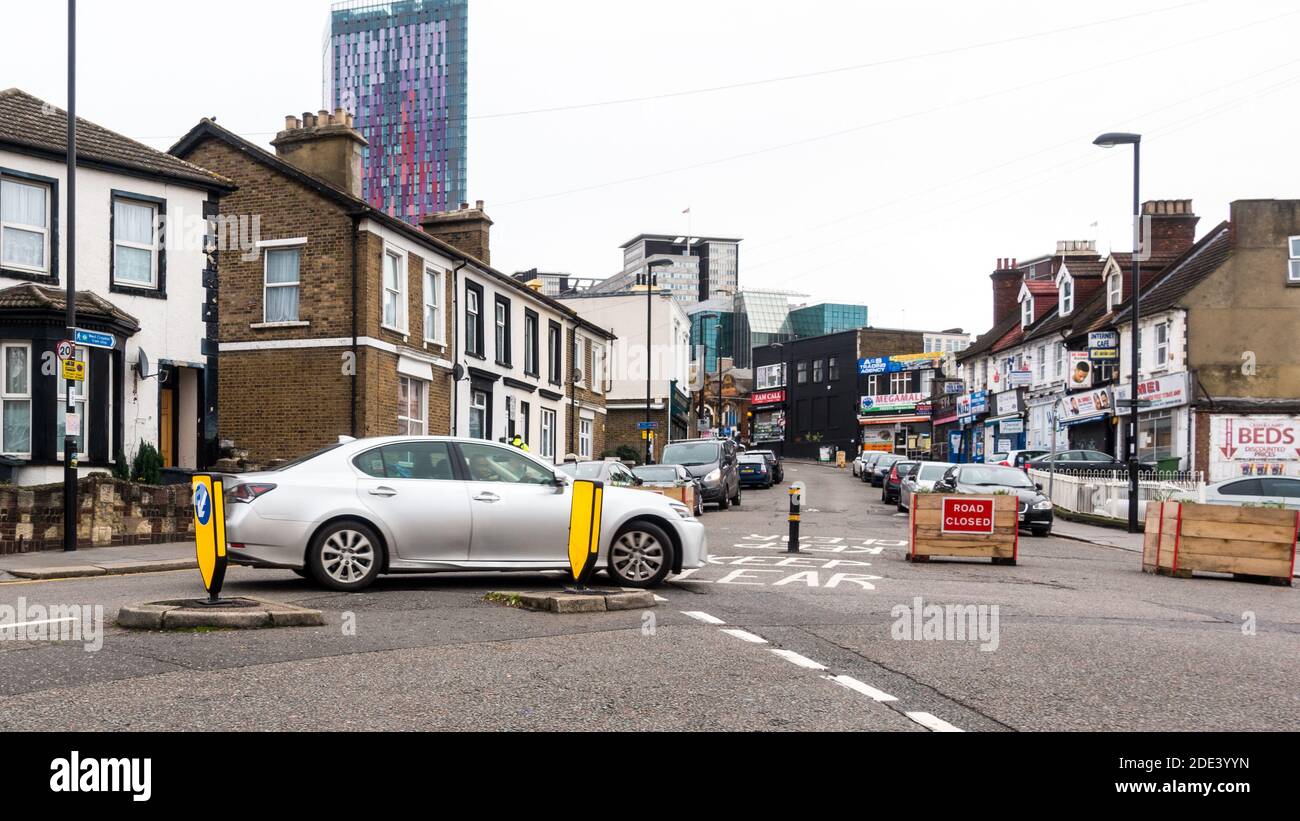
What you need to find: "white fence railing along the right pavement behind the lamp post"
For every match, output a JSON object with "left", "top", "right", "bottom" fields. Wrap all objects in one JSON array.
[{"left": 1030, "top": 470, "right": 1205, "bottom": 518}]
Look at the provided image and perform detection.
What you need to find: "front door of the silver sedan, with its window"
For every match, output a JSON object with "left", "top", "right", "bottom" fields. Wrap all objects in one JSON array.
[{"left": 456, "top": 443, "right": 569, "bottom": 565}]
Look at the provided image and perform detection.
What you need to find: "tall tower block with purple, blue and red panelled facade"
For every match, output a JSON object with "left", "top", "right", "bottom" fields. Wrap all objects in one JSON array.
[{"left": 322, "top": 0, "right": 469, "bottom": 225}]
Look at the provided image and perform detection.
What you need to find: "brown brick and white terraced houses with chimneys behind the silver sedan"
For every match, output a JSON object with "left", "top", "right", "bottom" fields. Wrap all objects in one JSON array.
[{"left": 172, "top": 109, "right": 610, "bottom": 462}]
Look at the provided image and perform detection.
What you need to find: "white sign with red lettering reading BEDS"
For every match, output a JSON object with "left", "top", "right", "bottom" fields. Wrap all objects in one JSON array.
[{"left": 1209, "top": 414, "right": 1300, "bottom": 482}]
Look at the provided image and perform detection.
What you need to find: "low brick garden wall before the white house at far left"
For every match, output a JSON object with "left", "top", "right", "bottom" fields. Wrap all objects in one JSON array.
[{"left": 0, "top": 474, "right": 194, "bottom": 553}]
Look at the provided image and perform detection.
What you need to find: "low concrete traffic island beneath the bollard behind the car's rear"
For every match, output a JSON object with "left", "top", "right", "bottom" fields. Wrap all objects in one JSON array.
[{"left": 117, "top": 596, "right": 325, "bottom": 630}]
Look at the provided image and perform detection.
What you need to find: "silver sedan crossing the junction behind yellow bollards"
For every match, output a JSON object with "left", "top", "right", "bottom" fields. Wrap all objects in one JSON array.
[{"left": 225, "top": 436, "right": 709, "bottom": 591}]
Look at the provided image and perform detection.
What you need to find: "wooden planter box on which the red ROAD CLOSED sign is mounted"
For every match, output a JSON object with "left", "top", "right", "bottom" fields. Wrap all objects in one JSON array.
[{"left": 907, "top": 494, "right": 1021, "bottom": 565}]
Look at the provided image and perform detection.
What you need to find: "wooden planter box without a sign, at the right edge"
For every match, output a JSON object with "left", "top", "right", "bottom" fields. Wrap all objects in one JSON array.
[{"left": 1141, "top": 501, "right": 1300, "bottom": 586}]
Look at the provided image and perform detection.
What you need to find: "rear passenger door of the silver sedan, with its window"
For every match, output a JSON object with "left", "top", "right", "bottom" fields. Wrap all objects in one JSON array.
[{"left": 352, "top": 440, "right": 472, "bottom": 561}]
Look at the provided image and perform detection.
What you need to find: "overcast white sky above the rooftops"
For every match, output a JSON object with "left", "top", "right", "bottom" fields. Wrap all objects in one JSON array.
[{"left": 0, "top": 0, "right": 1300, "bottom": 333}]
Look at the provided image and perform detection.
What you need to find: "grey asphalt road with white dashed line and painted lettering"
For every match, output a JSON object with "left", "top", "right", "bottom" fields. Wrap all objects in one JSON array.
[{"left": 0, "top": 465, "right": 1300, "bottom": 731}]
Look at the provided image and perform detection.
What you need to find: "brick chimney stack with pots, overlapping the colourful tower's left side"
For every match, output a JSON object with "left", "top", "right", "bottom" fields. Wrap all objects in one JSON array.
[{"left": 270, "top": 108, "right": 368, "bottom": 199}]
